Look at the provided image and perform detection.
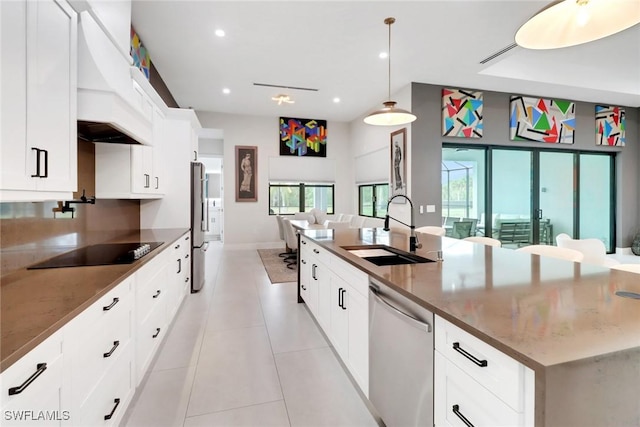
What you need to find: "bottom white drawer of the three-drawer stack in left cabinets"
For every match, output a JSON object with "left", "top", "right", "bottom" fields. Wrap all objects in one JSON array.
[{"left": 76, "top": 342, "right": 135, "bottom": 426}]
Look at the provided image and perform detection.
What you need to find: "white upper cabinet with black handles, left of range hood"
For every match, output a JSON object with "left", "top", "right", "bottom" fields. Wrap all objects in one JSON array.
[{"left": 0, "top": 0, "right": 77, "bottom": 201}]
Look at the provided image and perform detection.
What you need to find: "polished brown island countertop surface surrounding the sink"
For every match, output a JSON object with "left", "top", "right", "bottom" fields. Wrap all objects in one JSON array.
[{"left": 303, "top": 228, "right": 640, "bottom": 371}]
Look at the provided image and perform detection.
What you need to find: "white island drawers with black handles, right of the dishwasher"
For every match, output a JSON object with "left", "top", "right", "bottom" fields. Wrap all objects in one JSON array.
[{"left": 434, "top": 316, "right": 535, "bottom": 426}]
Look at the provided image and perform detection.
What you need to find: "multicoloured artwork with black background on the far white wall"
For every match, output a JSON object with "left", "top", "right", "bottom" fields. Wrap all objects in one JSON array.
[{"left": 280, "top": 117, "right": 327, "bottom": 157}]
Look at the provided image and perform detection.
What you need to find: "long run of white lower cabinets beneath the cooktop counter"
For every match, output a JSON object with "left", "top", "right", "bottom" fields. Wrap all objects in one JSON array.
[{"left": 0, "top": 232, "right": 191, "bottom": 427}]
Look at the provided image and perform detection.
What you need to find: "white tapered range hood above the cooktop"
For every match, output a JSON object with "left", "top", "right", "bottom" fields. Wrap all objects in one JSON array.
[{"left": 77, "top": 11, "right": 153, "bottom": 145}]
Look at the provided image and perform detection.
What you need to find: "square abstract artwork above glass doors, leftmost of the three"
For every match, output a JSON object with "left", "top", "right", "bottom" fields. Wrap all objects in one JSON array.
[{"left": 442, "top": 88, "right": 483, "bottom": 138}]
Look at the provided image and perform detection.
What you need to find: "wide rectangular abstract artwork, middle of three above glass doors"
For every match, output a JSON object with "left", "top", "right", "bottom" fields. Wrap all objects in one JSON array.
[{"left": 509, "top": 96, "right": 576, "bottom": 144}]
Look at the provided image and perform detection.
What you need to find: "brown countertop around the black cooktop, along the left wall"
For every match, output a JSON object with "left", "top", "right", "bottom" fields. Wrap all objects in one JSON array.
[{"left": 0, "top": 229, "right": 189, "bottom": 372}]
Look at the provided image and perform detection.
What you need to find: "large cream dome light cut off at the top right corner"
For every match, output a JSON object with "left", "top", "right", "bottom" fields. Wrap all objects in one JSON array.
[{"left": 515, "top": 0, "right": 640, "bottom": 49}]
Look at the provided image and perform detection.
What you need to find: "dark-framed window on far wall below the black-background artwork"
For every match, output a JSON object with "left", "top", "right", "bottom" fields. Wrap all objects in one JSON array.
[{"left": 269, "top": 182, "right": 335, "bottom": 215}]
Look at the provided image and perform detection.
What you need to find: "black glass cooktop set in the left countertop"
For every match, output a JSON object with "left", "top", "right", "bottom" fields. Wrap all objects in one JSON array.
[{"left": 27, "top": 242, "right": 164, "bottom": 270}]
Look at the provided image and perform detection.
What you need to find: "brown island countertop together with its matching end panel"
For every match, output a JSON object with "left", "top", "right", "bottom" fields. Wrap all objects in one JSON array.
[{"left": 303, "top": 228, "right": 640, "bottom": 426}]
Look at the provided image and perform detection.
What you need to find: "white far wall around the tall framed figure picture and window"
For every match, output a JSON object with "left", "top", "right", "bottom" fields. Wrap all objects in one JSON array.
[{"left": 197, "top": 111, "right": 357, "bottom": 247}]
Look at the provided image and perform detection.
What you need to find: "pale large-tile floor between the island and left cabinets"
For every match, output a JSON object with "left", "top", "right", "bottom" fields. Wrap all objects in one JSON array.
[{"left": 123, "top": 242, "right": 377, "bottom": 427}]
